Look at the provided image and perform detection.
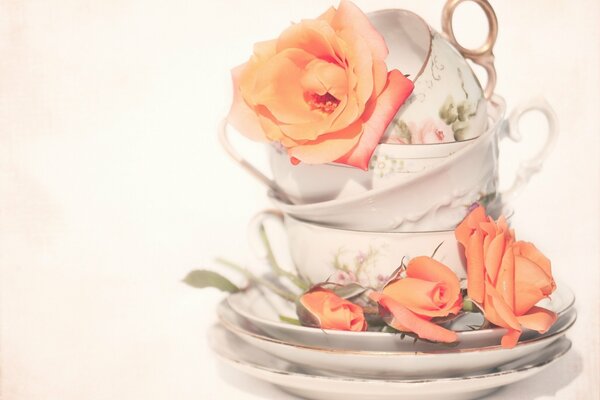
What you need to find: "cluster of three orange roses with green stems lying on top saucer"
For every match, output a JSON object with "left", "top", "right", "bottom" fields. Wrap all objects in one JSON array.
[{"left": 184, "top": 205, "right": 557, "bottom": 348}]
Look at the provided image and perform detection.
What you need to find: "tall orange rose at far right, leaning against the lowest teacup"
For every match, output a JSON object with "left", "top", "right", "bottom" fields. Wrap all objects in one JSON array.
[{"left": 455, "top": 206, "right": 556, "bottom": 348}]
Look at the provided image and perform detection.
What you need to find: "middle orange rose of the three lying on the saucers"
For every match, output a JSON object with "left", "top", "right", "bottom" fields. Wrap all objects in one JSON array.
[{"left": 369, "top": 257, "right": 462, "bottom": 343}]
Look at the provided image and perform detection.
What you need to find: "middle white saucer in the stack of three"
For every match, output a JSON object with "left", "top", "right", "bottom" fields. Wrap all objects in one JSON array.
[{"left": 218, "top": 302, "right": 577, "bottom": 378}]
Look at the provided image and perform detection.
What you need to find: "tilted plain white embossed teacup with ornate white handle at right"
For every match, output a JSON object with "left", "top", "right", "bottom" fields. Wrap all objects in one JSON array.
[{"left": 269, "top": 96, "right": 558, "bottom": 232}]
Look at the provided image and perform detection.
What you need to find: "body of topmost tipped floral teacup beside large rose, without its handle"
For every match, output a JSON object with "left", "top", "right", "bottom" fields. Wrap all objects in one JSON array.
[{"left": 369, "top": 9, "right": 493, "bottom": 144}]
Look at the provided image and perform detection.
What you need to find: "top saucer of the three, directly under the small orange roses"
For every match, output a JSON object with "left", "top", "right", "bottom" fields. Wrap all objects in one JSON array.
[{"left": 226, "top": 283, "right": 577, "bottom": 352}]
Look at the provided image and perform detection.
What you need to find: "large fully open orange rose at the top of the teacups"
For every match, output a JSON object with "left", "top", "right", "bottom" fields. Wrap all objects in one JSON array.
[{"left": 229, "top": 0, "right": 413, "bottom": 169}]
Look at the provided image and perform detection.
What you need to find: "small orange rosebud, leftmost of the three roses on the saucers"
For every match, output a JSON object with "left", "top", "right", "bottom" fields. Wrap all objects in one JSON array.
[{"left": 297, "top": 288, "right": 367, "bottom": 332}]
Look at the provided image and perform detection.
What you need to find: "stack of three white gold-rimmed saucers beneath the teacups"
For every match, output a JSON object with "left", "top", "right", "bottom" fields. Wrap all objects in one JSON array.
[{"left": 209, "top": 284, "right": 577, "bottom": 400}]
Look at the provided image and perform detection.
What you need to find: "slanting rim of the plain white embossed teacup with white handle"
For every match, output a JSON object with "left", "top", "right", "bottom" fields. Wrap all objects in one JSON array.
[{"left": 267, "top": 95, "right": 506, "bottom": 214}]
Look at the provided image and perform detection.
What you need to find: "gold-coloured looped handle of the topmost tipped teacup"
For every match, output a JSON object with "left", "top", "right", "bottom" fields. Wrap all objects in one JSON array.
[{"left": 442, "top": 0, "right": 498, "bottom": 99}]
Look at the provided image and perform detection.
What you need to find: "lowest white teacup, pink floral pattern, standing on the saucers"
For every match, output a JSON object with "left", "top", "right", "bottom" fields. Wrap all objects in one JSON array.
[{"left": 249, "top": 211, "right": 474, "bottom": 288}]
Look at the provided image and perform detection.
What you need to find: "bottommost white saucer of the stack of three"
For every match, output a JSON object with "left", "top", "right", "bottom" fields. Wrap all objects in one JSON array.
[{"left": 209, "top": 326, "right": 571, "bottom": 400}]
